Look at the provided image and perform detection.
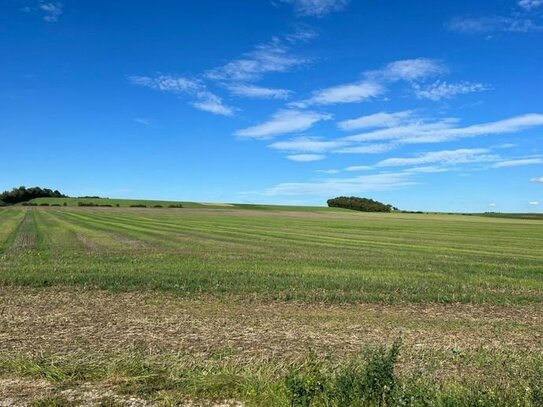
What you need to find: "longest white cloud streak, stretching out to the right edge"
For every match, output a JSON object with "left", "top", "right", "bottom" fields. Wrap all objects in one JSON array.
[{"left": 344, "top": 113, "right": 543, "bottom": 144}]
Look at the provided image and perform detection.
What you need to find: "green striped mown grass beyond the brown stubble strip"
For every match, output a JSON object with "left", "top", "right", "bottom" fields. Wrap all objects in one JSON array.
[{"left": 0, "top": 208, "right": 543, "bottom": 304}]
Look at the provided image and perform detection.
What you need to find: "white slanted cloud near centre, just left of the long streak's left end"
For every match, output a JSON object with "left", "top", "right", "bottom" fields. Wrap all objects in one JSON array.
[{"left": 235, "top": 110, "right": 332, "bottom": 139}]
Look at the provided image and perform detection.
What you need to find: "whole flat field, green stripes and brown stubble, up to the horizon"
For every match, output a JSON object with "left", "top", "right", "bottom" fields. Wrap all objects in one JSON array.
[{"left": 0, "top": 207, "right": 543, "bottom": 407}]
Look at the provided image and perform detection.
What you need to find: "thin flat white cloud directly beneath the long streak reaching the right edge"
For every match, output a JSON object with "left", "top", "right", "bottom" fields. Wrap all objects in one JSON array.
[{"left": 377, "top": 148, "right": 499, "bottom": 167}]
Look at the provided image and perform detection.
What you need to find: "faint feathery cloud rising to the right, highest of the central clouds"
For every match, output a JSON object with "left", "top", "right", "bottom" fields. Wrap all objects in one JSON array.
[{"left": 205, "top": 38, "right": 309, "bottom": 82}]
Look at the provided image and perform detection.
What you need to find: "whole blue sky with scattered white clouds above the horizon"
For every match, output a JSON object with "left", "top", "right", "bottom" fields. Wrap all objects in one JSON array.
[{"left": 0, "top": 0, "right": 543, "bottom": 212}]
